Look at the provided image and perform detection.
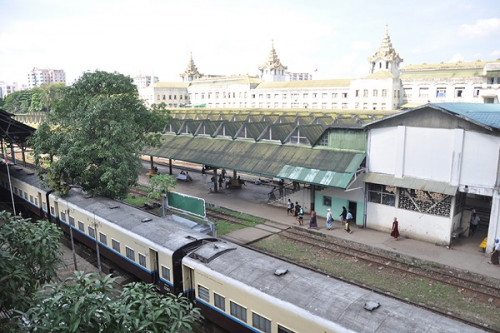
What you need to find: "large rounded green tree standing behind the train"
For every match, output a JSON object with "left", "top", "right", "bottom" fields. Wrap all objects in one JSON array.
[{"left": 31, "top": 71, "right": 168, "bottom": 198}]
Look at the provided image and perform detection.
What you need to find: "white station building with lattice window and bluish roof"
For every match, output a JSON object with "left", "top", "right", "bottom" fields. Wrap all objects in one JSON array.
[{"left": 363, "top": 103, "right": 500, "bottom": 249}]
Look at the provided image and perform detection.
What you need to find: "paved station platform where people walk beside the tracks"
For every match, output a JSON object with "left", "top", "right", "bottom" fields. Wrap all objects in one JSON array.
[{"left": 139, "top": 161, "right": 500, "bottom": 279}]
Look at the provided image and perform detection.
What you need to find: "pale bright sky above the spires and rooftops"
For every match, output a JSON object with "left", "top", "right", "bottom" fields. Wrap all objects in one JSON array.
[{"left": 0, "top": 0, "right": 500, "bottom": 84}]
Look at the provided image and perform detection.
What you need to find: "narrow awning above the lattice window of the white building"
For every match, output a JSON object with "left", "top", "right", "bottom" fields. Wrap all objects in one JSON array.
[{"left": 362, "top": 172, "right": 458, "bottom": 196}]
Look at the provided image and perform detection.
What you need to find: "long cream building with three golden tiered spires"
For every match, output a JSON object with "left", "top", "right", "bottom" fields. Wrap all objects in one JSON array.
[{"left": 140, "top": 28, "right": 500, "bottom": 110}]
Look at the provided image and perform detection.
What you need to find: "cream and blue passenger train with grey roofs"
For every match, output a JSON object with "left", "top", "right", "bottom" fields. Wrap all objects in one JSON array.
[{"left": 0, "top": 162, "right": 483, "bottom": 333}]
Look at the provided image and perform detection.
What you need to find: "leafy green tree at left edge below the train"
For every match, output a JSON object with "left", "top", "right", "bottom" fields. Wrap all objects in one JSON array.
[{"left": 0, "top": 211, "right": 61, "bottom": 310}]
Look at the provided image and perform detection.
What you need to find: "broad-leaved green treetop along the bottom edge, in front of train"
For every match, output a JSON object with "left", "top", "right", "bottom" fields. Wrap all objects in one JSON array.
[{"left": 17, "top": 272, "right": 200, "bottom": 333}]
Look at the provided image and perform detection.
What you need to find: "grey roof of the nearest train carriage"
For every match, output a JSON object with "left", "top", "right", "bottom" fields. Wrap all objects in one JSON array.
[{"left": 184, "top": 241, "right": 482, "bottom": 332}]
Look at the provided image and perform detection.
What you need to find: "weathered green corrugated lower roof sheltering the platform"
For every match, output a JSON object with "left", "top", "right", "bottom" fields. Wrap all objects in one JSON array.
[{"left": 142, "top": 134, "right": 365, "bottom": 188}]
